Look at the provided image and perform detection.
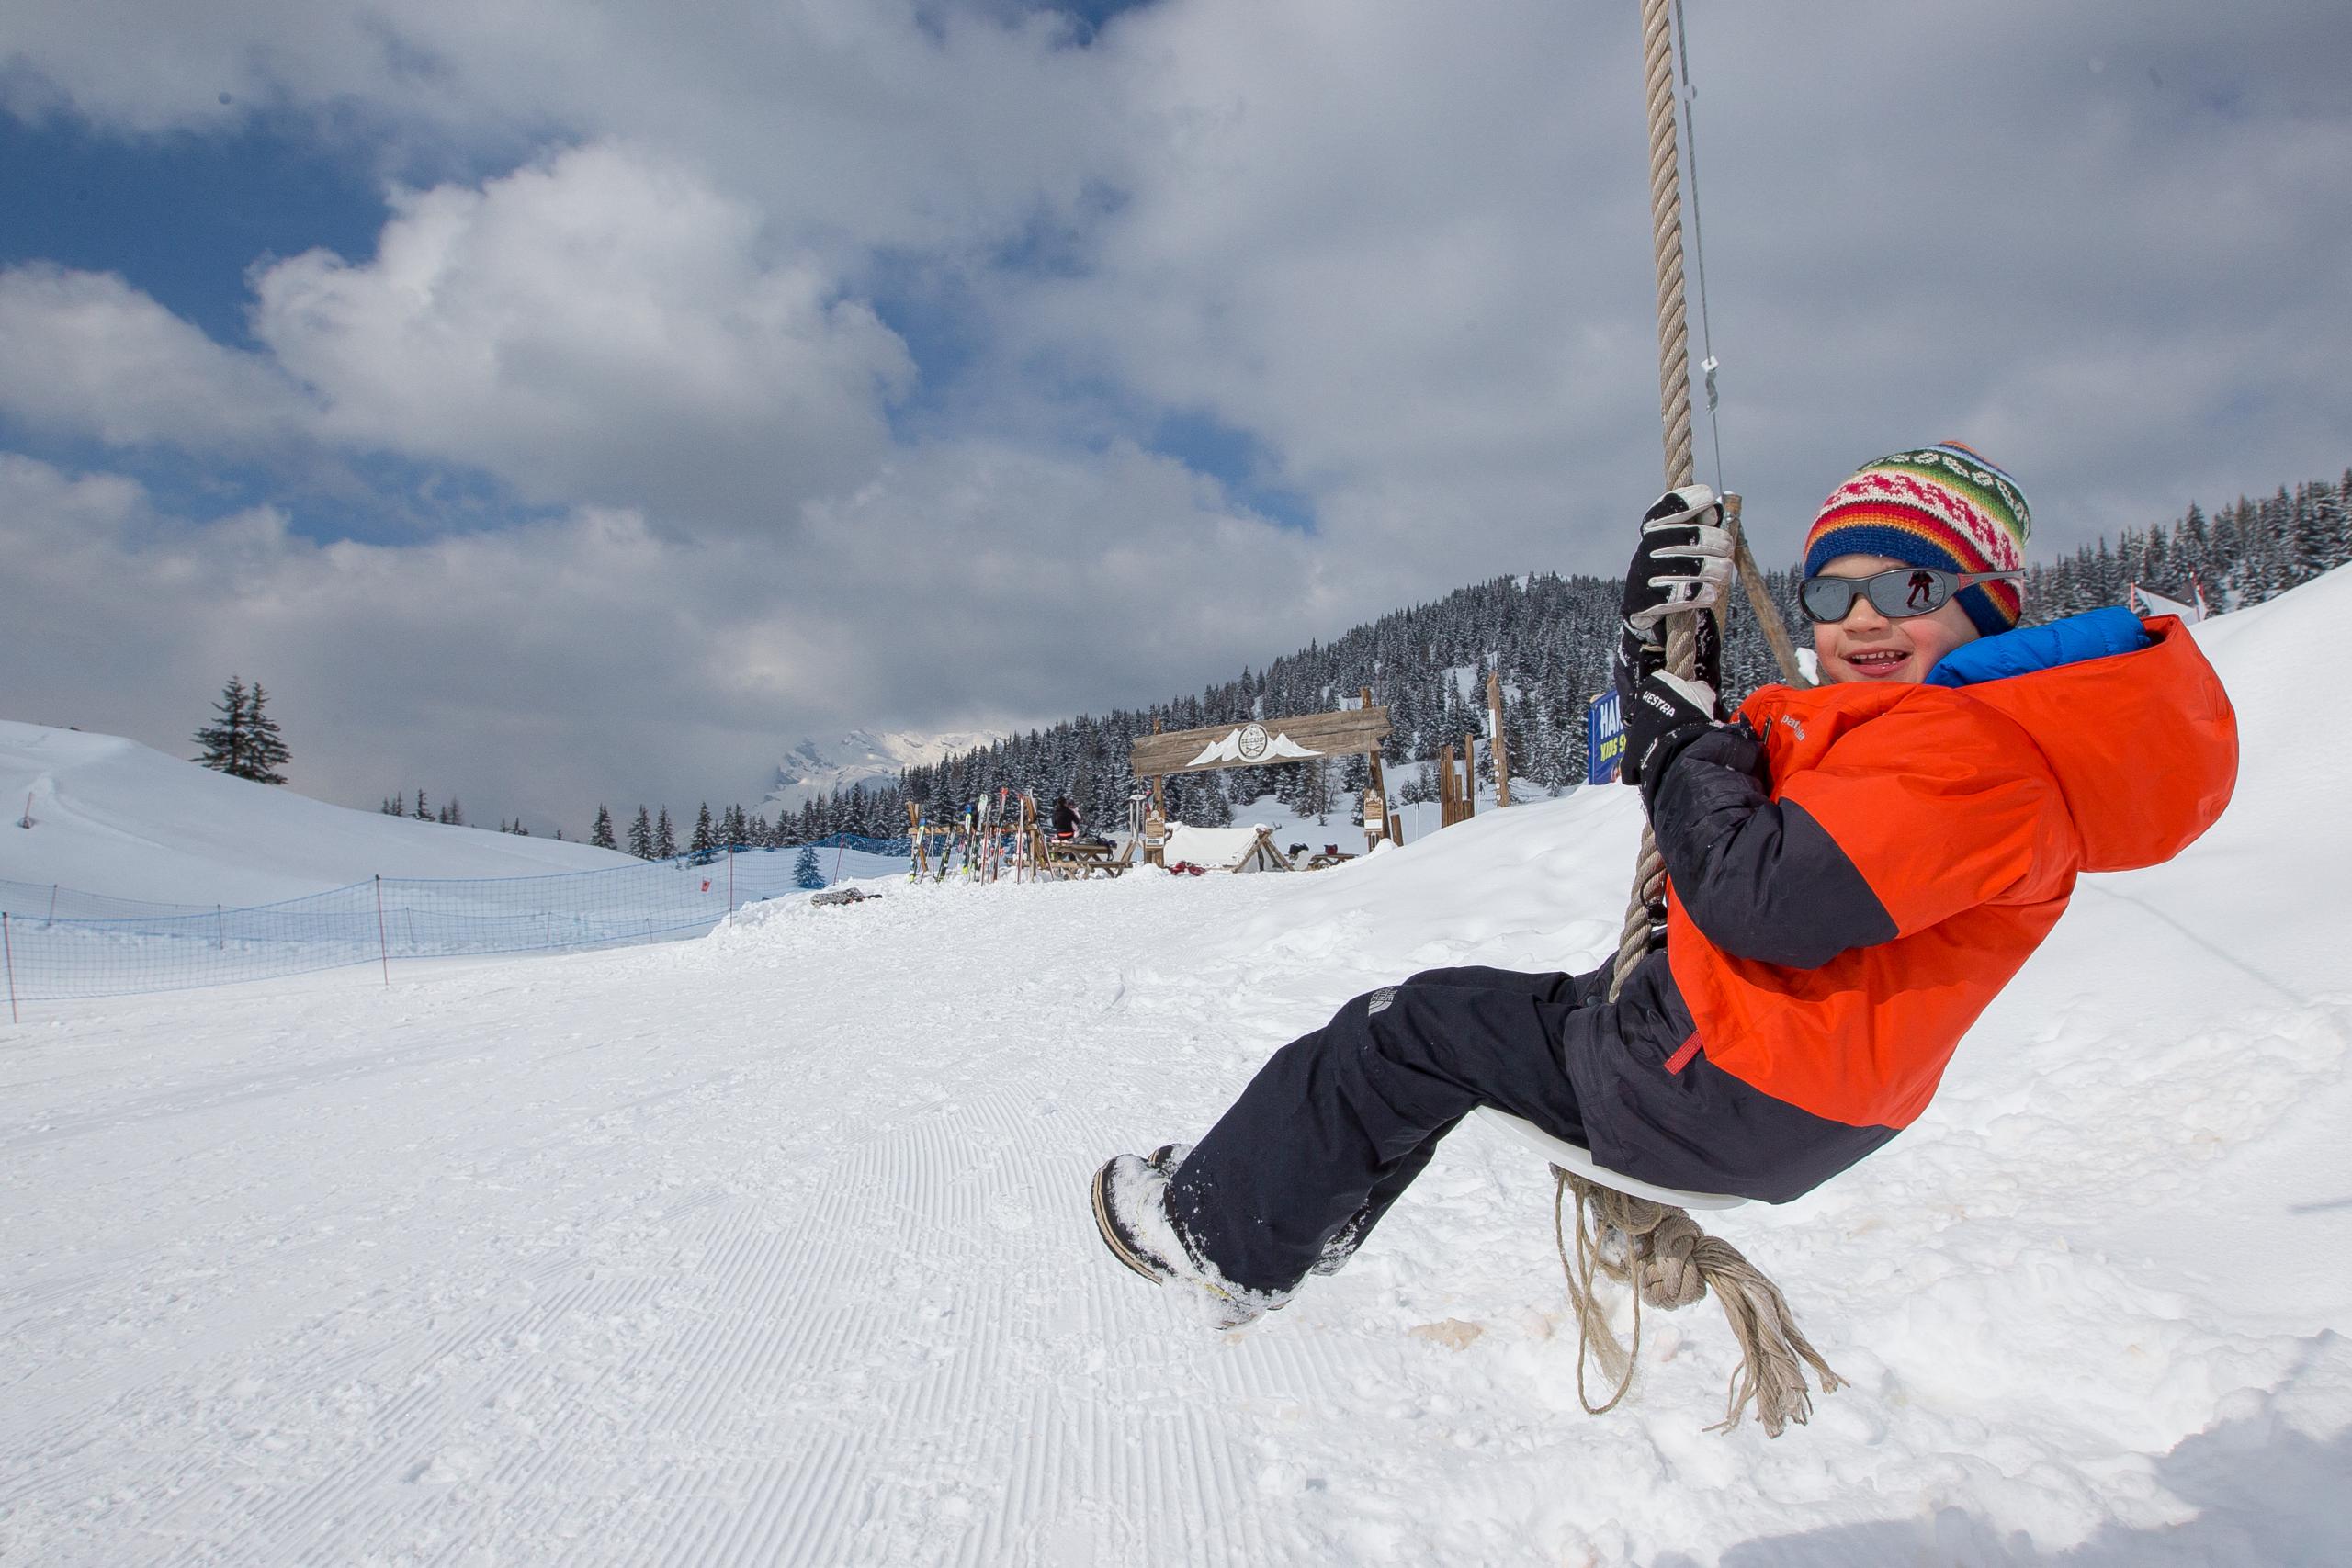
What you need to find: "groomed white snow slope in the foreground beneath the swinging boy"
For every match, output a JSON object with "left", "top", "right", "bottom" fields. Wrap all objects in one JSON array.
[{"left": 0, "top": 573, "right": 2352, "bottom": 1568}]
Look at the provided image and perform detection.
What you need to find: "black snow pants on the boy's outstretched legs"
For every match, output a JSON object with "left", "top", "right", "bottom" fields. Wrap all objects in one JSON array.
[{"left": 1169, "top": 968, "right": 1609, "bottom": 1293}]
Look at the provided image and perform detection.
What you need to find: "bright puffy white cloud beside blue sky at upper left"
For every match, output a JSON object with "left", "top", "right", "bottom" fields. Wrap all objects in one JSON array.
[{"left": 254, "top": 146, "right": 912, "bottom": 526}]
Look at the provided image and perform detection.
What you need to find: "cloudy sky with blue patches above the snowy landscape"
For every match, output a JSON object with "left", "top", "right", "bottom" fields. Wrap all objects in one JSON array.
[{"left": 0, "top": 0, "right": 2352, "bottom": 832}]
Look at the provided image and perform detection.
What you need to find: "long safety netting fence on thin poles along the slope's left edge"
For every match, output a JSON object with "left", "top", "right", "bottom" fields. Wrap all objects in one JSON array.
[{"left": 0, "top": 835, "right": 910, "bottom": 1004}]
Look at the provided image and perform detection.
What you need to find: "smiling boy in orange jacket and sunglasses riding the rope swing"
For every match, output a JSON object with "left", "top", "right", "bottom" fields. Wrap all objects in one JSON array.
[{"left": 1093, "top": 442, "right": 2237, "bottom": 1325}]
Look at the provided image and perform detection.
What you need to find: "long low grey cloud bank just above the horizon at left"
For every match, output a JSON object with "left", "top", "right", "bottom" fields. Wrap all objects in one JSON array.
[{"left": 0, "top": 445, "right": 1334, "bottom": 829}]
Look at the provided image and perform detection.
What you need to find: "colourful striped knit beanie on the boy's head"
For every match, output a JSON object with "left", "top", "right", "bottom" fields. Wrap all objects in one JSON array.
[{"left": 1804, "top": 442, "right": 2034, "bottom": 637}]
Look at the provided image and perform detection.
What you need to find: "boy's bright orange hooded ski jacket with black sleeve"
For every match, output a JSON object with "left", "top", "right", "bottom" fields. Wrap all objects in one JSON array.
[{"left": 1654, "top": 618, "right": 2237, "bottom": 1135}]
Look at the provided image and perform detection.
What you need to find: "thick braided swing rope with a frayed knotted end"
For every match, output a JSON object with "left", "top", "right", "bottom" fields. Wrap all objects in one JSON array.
[{"left": 1553, "top": 0, "right": 1844, "bottom": 1437}]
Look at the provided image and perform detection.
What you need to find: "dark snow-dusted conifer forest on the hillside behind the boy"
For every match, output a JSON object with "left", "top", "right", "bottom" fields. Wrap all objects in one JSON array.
[{"left": 611, "top": 468, "right": 2352, "bottom": 853}]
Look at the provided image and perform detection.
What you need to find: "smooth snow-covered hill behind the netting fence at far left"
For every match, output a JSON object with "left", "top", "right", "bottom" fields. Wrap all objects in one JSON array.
[{"left": 0, "top": 719, "right": 630, "bottom": 905}]
